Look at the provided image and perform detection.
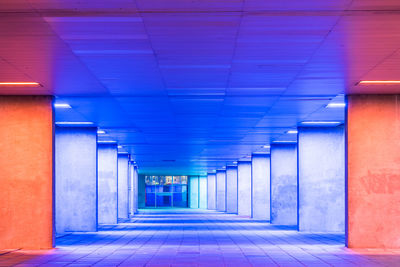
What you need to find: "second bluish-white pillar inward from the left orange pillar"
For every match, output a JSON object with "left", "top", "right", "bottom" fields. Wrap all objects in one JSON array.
[{"left": 97, "top": 144, "right": 118, "bottom": 224}]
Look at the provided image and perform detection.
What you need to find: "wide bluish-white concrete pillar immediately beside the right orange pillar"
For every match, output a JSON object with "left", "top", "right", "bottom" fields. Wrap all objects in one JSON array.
[{"left": 298, "top": 126, "right": 345, "bottom": 232}]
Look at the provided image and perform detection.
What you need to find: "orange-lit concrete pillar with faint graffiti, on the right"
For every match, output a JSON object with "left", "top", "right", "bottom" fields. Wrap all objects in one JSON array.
[{"left": 347, "top": 95, "right": 400, "bottom": 248}]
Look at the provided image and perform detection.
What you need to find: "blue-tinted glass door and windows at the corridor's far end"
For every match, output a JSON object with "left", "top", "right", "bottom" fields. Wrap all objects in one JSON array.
[{"left": 145, "top": 176, "right": 188, "bottom": 208}]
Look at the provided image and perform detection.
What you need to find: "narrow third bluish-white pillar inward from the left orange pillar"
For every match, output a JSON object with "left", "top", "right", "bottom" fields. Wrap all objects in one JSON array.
[{"left": 118, "top": 154, "right": 129, "bottom": 219}]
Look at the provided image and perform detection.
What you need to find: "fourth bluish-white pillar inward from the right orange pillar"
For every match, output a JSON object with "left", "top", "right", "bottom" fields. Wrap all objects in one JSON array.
[{"left": 238, "top": 161, "right": 252, "bottom": 217}]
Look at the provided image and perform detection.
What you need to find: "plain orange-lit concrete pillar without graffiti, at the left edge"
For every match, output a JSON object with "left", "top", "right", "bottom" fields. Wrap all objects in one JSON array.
[{"left": 0, "top": 96, "right": 54, "bottom": 249}]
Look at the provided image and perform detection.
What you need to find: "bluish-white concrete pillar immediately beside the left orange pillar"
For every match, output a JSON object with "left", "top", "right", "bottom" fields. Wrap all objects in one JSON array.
[{"left": 55, "top": 127, "right": 97, "bottom": 233}]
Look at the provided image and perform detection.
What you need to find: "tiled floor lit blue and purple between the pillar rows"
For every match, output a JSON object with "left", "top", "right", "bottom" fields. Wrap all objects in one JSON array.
[{"left": 0, "top": 209, "right": 400, "bottom": 267}]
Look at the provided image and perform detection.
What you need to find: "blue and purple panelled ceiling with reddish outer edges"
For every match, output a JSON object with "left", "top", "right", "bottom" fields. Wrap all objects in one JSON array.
[{"left": 0, "top": 0, "right": 400, "bottom": 174}]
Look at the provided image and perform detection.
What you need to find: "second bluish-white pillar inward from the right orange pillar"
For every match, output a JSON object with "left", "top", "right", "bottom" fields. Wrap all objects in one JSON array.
[{"left": 271, "top": 144, "right": 297, "bottom": 225}]
